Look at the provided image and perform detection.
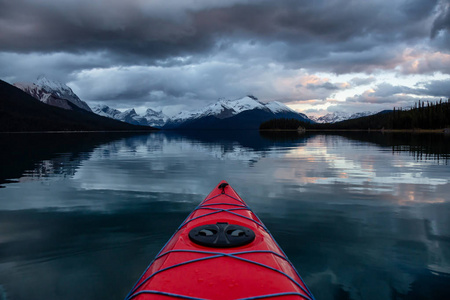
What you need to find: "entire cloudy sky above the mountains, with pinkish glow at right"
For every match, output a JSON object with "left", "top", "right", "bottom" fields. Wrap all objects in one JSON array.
[{"left": 0, "top": 0, "right": 450, "bottom": 115}]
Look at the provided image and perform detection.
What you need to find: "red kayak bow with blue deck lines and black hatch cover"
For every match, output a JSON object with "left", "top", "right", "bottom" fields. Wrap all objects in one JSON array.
[{"left": 126, "top": 181, "right": 314, "bottom": 300}]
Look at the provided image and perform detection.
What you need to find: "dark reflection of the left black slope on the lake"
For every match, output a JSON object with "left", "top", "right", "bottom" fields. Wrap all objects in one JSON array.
[{"left": 0, "top": 133, "right": 153, "bottom": 187}]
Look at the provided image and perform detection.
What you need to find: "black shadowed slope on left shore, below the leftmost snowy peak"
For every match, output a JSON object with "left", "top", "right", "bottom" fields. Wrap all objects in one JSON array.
[{"left": 0, "top": 80, "right": 155, "bottom": 132}]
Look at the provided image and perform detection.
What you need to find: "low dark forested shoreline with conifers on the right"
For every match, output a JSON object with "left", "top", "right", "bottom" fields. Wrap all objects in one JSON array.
[{"left": 260, "top": 99, "right": 450, "bottom": 130}]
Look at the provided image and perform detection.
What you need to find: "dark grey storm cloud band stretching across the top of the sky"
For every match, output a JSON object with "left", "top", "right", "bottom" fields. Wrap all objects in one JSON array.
[{"left": 0, "top": 0, "right": 445, "bottom": 64}]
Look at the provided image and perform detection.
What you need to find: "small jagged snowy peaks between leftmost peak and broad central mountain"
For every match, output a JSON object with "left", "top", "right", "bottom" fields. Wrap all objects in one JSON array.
[{"left": 92, "top": 105, "right": 169, "bottom": 127}]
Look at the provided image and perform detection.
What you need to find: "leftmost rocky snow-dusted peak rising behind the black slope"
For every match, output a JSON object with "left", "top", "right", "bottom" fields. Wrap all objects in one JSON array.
[{"left": 14, "top": 76, "right": 92, "bottom": 112}]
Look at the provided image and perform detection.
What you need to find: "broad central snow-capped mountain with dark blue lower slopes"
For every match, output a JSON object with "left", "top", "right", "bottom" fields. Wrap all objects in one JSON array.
[{"left": 164, "top": 96, "right": 311, "bottom": 129}]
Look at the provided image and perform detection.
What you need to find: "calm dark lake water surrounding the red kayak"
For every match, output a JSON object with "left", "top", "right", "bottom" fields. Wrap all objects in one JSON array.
[{"left": 0, "top": 132, "right": 450, "bottom": 300}]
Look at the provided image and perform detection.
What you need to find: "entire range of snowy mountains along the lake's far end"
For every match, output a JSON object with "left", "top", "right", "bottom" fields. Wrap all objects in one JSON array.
[{"left": 6, "top": 76, "right": 386, "bottom": 130}]
